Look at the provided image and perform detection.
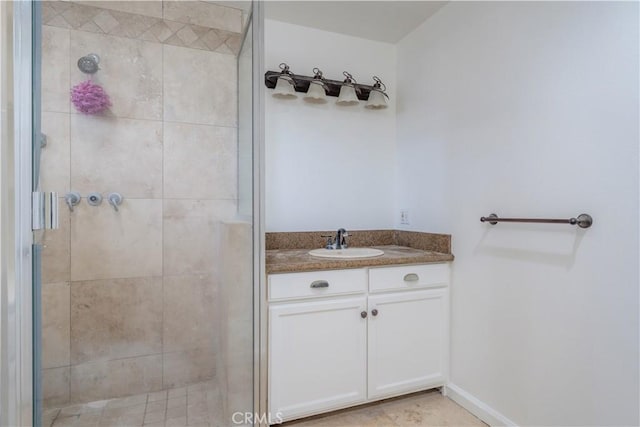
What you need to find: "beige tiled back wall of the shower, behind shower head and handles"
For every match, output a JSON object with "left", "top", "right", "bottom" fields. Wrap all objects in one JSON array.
[{"left": 41, "top": 1, "right": 243, "bottom": 406}]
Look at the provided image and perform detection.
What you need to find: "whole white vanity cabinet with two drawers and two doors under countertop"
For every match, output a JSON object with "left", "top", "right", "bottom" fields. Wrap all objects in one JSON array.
[{"left": 268, "top": 264, "right": 449, "bottom": 420}]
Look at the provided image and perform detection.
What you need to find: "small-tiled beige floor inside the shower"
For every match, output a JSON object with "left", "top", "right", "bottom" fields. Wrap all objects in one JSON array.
[{"left": 42, "top": 381, "right": 222, "bottom": 427}]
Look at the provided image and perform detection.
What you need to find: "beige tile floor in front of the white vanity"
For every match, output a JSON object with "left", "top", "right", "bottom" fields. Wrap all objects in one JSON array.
[{"left": 283, "top": 390, "right": 487, "bottom": 427}]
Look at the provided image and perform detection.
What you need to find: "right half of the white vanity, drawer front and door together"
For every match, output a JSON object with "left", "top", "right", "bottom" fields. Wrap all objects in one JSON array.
[{"left": 368, "top": 264, "right": 450, "bottom": 399}]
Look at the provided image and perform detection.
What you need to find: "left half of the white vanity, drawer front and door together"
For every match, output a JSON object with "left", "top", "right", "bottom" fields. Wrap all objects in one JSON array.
[{"left": 268, "top": 269, "right": 368, "bottom": 420}]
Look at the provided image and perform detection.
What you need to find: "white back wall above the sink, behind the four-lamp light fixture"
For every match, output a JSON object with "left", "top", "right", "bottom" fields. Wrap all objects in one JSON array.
[{"left": 265, "top": 18, "right": 396, "bottom": 231}]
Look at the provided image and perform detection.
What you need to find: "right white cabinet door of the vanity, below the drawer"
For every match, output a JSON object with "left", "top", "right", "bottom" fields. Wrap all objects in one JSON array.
[{"left": 368, "top": 289, "right": 448, "bottom": 399}]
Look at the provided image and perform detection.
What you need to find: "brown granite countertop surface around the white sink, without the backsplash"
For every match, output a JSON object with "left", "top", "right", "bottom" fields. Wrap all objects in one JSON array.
[{"left": 266, "top": 245, "right": 453, "bottom": 274}]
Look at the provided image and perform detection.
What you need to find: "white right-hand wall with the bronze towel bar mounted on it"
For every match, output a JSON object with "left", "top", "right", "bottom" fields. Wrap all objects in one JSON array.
[{"left": 397, "top": 2, "right": 639, "bottom": 425}]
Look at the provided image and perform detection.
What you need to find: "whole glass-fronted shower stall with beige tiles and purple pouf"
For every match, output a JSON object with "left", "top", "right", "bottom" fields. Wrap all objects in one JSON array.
[{"left": 2, "top": 0, "right": 262, "bottom": 427}]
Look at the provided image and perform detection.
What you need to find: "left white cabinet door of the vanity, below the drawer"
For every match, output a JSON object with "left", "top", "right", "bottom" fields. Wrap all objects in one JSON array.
[{"left": 269, "top": 296, "right": 367, "bottom": 420}]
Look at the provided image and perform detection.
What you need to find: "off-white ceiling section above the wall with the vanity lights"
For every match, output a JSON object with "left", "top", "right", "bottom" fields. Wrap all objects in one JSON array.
[{"left": 264, "top": 0, "right": 447, "bottom": 43}]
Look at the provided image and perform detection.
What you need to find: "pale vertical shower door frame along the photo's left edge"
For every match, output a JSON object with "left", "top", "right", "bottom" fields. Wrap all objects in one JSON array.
[{"left": 0, "top": 1, "right": 34, "bottom": 426}]
